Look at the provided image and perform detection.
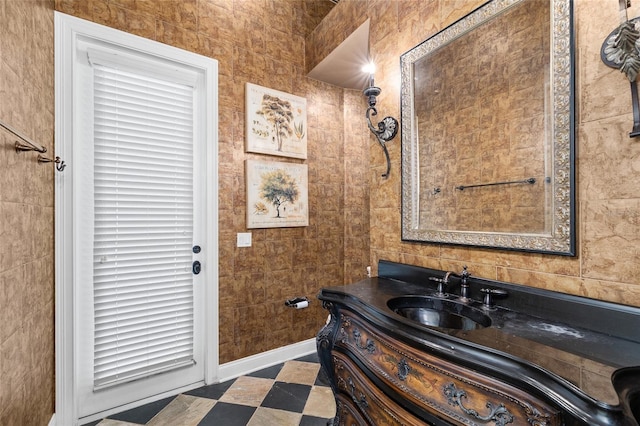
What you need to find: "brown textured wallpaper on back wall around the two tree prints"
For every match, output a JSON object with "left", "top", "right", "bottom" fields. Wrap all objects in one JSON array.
[{"left": 56, "top": 0, "right": 369, "bottom": 363}]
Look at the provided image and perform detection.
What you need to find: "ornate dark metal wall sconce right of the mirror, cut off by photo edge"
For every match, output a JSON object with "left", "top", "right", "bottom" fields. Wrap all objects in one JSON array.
[{"left": 600, "top": 0, "right": 640, "bottom": 138}]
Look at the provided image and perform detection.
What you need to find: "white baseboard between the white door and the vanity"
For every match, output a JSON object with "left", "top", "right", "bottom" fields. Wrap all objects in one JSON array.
[{"left": 218, "top": 338, "right": 316, "bottom": 383}]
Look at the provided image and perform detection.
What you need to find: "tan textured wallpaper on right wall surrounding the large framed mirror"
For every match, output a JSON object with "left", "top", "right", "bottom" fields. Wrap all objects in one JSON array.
[{"left": 307, "top": 0, "right": 640, "bottom": 306}]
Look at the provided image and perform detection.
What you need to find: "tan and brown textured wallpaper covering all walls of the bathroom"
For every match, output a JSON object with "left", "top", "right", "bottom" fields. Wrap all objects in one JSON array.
[{"left": 0, "top": 0, "right": 640, "bottom": 425}]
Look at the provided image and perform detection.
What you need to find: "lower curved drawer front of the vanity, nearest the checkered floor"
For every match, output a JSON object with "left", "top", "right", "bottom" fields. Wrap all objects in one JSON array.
[{"left": 333, "top": 353, "right": 425, "bottom": 426}]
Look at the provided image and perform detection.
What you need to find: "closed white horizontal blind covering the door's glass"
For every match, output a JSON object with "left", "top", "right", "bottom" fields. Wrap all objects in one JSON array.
[{"left": 92, "top": 63, "right": 194, "bottom": 389}]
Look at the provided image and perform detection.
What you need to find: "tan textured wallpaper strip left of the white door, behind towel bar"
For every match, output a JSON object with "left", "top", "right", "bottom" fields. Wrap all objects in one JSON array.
[{"left": 0, "top": 0, "right": 54, "bottom": 426}]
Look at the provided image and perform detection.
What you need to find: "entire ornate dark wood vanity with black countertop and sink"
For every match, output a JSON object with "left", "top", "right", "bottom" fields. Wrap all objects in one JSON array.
[{"left": 317, "top": 261, "right": 640, "bottom": 426}]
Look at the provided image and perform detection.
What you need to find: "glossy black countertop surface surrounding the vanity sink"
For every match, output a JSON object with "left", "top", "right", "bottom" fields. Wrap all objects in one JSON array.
[{"left": 320, "top": 271, "right": 640, "bottom": 406}]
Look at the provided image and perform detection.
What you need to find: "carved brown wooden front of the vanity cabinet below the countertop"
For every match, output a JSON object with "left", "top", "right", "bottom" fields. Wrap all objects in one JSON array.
[{"left": 318, "top": 303, "right": 562, "bottom": 426}]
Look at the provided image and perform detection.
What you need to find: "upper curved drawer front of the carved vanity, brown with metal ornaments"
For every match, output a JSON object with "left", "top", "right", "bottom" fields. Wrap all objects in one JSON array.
[{"left": 334, "top": 310, "right": 562, "bottom": 426}]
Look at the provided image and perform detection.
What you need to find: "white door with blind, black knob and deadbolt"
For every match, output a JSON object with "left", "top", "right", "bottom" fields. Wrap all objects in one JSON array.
[{"left": 53, "top": 13, "right": 217, "bottom": 421}]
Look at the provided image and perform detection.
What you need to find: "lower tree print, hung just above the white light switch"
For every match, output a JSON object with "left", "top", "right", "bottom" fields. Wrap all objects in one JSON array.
[{"left": 246, "top": 160, "right": 309, "bottom": 228}]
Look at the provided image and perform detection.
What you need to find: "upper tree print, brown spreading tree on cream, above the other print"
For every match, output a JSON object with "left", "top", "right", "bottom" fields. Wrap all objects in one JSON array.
[{"left": 245, "top": 83, "right": 307, "bottom": 159}]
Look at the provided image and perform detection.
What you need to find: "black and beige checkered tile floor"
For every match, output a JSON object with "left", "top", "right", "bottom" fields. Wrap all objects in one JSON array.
[{"left": 85, "top": 354, "right": 336, "bottom": 426}]
